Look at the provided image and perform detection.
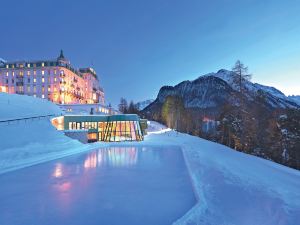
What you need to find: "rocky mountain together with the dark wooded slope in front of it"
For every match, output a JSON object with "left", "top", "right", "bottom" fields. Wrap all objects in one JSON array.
[{"left": 142, "top": 69, "right": 300, "bottom": 169}]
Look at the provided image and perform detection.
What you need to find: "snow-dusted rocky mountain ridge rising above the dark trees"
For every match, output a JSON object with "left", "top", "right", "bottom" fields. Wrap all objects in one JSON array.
[{"left": 146, "top": 69, "right": 299, "bottom": 109}]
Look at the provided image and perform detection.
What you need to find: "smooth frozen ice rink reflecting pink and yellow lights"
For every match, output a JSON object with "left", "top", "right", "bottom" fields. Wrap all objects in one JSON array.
[{"left": 0, "top": 146, "right": 196, "bottom": 225}]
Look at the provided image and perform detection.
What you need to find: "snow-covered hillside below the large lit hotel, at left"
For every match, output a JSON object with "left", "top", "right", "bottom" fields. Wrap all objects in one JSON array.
[{"left": 0, "top": 93, "right": 89, "bottom": 174}]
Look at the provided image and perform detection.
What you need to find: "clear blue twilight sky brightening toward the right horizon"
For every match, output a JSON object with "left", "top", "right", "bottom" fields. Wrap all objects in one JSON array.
[{"left": 0, "top": 0, "right": 300, "bottom": 106}]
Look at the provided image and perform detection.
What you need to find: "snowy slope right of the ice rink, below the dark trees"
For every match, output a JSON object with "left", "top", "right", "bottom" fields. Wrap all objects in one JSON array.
[{"left": 141, "top": 123, "right": 300, "bottom": 225}]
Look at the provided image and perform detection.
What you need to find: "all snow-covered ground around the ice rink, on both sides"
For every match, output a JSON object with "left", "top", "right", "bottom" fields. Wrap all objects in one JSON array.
[{"left": 0, "top": 93, "right": 300, "bottom": 225}]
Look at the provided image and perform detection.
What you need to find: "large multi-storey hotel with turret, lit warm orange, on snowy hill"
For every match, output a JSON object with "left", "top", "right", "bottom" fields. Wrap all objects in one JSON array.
[{"left": 0, "top": 51, "right": 104, "bottom": 105}]
